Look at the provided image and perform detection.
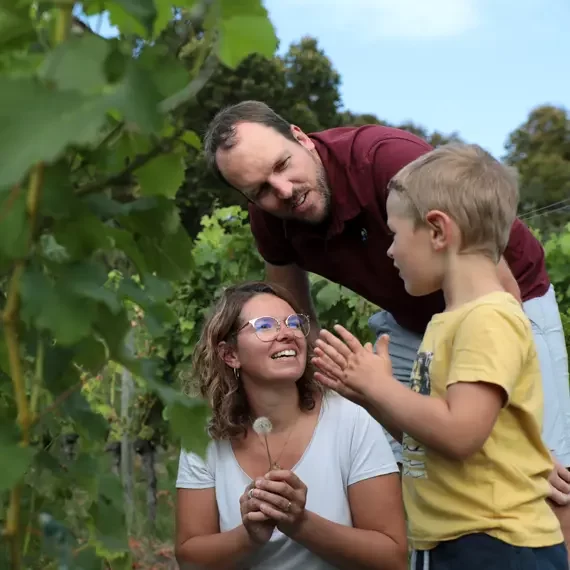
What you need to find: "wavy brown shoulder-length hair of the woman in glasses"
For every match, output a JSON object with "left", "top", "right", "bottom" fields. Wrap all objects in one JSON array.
[{"left": 192, "top": 281, "right": 322, "bottom": 439}]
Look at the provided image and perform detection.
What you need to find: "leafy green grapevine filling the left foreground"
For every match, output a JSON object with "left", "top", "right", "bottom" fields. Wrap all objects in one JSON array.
[{"left": 0, "top": 0, "right": 277, "bottom": 570}]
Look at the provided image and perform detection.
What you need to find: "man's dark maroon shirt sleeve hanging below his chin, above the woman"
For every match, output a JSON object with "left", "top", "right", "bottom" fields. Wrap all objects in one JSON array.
[{"left": 249, "top": 204, "right": 296, "bottom": 265}]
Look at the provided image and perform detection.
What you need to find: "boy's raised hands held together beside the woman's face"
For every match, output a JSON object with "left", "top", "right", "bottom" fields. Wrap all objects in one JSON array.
[{"left": 312, "top": 325, "right": 392, "bottom": 404}]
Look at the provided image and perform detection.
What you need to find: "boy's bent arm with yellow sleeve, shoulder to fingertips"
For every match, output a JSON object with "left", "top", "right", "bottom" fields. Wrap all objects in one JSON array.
[{"left": 315, "top": 306, "right": 530, "bottom": 459}]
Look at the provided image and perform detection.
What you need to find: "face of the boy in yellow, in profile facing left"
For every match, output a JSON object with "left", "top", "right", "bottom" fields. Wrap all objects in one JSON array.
[{"left": 386, "top": 192, "right": 443, "bottom": 297}]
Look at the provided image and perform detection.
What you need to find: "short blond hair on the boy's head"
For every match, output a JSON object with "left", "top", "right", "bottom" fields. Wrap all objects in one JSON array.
[{"left": 388, "top": 143, "right": 519, "bottom": 262}]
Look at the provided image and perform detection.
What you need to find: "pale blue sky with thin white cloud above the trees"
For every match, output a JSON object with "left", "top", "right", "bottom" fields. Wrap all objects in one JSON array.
[{"left": 86, "top": 0, "right": 570, "bottom": 158}]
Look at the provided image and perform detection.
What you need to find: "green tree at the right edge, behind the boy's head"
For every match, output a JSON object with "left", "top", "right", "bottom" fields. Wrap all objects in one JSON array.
[{"left": 505, "top": 105, "right": 570, "bottom": 231}]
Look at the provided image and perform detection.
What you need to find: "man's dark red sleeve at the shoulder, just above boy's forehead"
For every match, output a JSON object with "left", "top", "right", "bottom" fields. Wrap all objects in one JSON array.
[{"left": 369, "top": 137, "right": 432, "bottom": 201}]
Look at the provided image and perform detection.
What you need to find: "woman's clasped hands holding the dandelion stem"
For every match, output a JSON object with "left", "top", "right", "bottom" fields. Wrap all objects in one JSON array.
[{"left": 240, "top": 470, "right": 307, "bottom": 543}]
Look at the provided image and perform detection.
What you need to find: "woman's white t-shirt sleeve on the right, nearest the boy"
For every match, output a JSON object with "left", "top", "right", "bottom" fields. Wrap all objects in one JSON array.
[{"left": 347, "top": 407, "right": 398, "bottom": 486}]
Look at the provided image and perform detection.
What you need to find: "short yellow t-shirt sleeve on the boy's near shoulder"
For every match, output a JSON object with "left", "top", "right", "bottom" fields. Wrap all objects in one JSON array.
[{"left": 447, "top": 305, "right": 532, "bottom": 397}]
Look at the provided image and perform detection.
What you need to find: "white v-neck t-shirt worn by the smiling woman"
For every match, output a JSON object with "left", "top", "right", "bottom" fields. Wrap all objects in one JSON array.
[{"left": 176, "top": 393, "right": 398, "bottom": 570}]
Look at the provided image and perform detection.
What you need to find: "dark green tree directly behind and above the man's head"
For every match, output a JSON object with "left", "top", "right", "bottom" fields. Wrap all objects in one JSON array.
[{"left": 177, "top": 33, "right": 340, "bottom": 236}]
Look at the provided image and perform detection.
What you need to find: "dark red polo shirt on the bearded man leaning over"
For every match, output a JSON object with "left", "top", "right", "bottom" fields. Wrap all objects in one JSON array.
[{"left": 249, "top": 125, "right": 549, "bottom": 333}]
